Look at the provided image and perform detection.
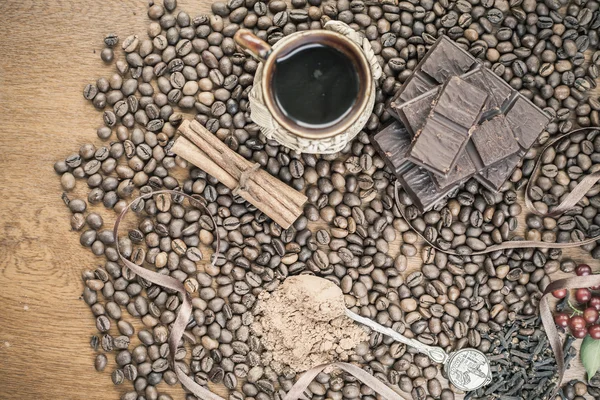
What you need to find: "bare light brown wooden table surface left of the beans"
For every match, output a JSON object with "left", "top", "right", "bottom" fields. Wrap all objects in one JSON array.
[{"left": 0, "top": 0, "right": 589, "bottom": 400}]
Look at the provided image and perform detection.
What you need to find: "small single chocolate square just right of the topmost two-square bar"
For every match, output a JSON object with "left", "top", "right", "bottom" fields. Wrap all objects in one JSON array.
[{"left": 471, "top": 114, "right": 520, "bottom": 165}]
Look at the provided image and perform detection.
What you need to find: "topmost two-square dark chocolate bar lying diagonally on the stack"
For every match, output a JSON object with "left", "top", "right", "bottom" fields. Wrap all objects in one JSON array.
[{"left": 408, "top": 76, "right": 488, "bottom": 176}]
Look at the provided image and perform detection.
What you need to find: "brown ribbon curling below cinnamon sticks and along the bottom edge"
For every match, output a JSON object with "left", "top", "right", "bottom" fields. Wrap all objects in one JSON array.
[{"left": 113, "top": 190, "right": 406, "bottom": 400}]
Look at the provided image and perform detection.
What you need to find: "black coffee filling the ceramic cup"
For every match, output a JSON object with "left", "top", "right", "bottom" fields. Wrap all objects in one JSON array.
[{"left": 272, "top": 44, "right": 359, "bottom": 128}]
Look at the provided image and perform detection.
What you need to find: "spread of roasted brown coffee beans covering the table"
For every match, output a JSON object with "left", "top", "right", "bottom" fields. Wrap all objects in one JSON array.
[{"left": 54, "top": 0, "right": 600, "bottom": 400}]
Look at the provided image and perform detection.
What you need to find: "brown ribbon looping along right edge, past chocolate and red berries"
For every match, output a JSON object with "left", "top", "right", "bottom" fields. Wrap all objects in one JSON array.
[{"left": 394, "top": 127, "right": 600, "bottom": 394}]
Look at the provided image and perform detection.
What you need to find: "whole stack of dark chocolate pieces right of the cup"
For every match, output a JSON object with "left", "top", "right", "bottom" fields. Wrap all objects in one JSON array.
[{"left": 371, "top": 36, "right": 550, "bottom": 211}]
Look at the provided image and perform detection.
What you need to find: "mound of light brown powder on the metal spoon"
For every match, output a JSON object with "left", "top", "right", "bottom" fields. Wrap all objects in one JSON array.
[{"left": 257, "top": 275, "right": 369, "bottom": 372}]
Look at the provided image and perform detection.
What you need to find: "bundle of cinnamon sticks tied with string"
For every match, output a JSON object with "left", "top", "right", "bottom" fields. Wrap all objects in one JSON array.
[{"left": 171, "top": 120, "right": 307, "bottom": 229}]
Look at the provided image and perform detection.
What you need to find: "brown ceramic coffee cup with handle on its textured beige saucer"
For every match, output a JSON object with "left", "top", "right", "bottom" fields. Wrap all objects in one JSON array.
[{"left": 234, "top": 21, "right": 381, "bottom": 153}]
